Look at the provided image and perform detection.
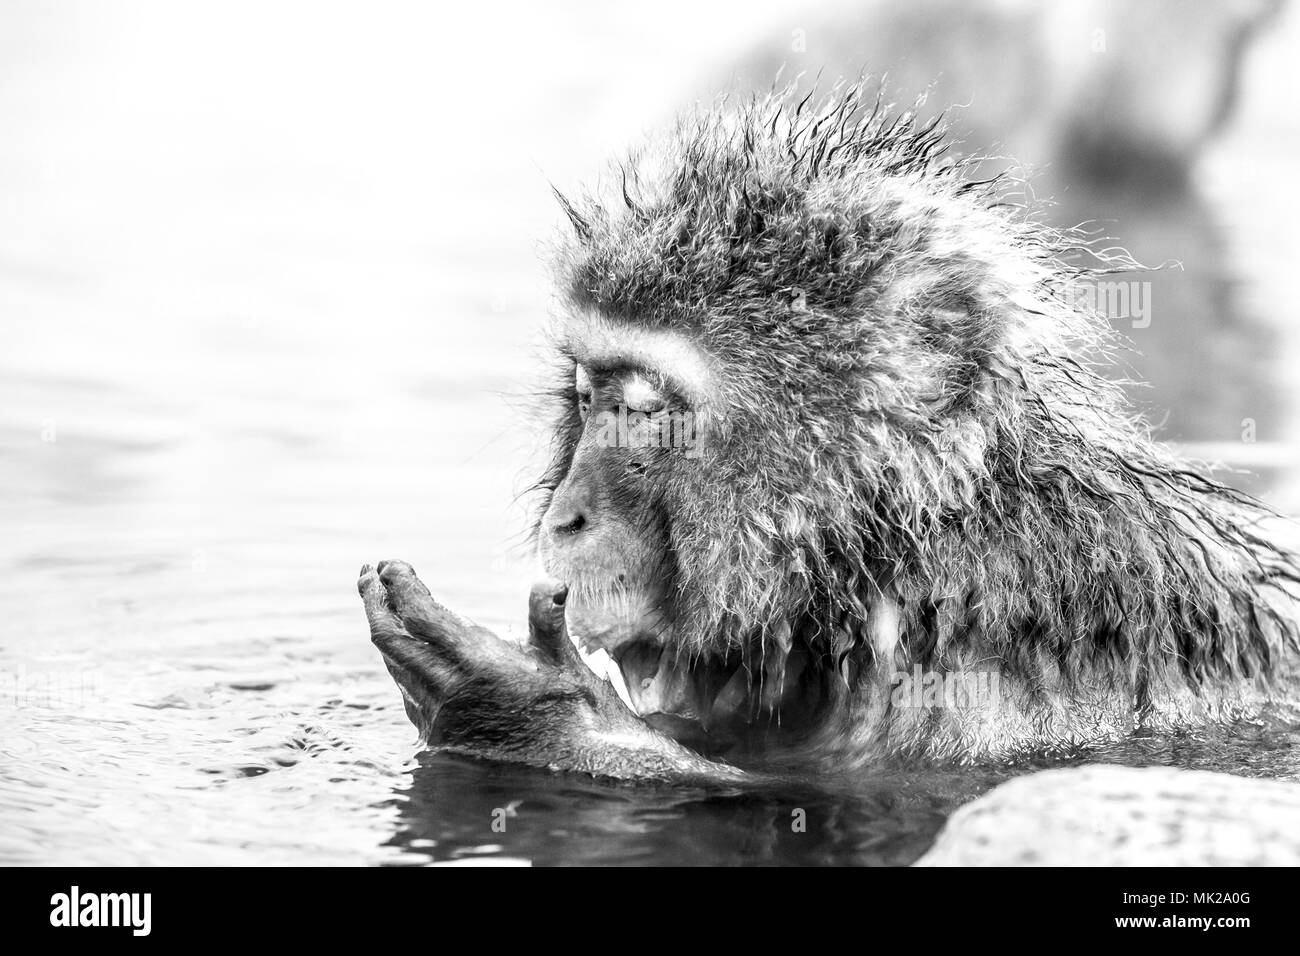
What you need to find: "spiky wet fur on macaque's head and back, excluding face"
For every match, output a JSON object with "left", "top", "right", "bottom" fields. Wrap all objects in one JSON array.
[{"left": 542, "top": 85, "right": 1297, "bottom": 697}]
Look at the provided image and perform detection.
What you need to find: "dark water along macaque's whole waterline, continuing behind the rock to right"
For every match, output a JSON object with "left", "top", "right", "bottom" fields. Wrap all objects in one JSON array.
[{"left": 391, "top": 714, "right": 1300, "bottom": 866}]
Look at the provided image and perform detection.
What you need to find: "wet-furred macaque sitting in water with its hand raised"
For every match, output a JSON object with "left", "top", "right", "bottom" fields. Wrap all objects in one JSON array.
[{"left": 360, "top": 86, "right": 1300, "bottom": 780}]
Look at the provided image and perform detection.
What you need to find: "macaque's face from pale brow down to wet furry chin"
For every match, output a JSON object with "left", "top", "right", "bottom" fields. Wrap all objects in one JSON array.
[{"left": 537, "top": 317, "right": 822, "bottom": 749}]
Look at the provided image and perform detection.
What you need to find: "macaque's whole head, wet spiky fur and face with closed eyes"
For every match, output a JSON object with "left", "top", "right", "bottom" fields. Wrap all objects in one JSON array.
[{"left": 536, "top": 88, "right": 1112, "bottom": 737}]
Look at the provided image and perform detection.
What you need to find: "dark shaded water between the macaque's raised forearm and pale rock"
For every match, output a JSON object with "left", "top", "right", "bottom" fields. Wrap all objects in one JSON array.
[{"left": 393, "top": 754, "right": 977, "bottom": 865}]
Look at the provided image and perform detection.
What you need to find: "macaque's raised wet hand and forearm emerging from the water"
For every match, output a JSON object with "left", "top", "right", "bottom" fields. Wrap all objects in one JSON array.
[{"left": 358, "top": 561, "right": 745, "bottom": 783}]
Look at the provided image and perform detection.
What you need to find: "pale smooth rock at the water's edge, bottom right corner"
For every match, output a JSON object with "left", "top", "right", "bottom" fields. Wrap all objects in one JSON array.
[{"left": 917, "top": 765, "right": 1300, "bottom": 866}]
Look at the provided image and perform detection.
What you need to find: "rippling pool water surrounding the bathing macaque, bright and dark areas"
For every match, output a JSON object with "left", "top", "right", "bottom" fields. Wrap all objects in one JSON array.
[{"left": 0, "top": 4, "right": 1300, "bottom": 865}]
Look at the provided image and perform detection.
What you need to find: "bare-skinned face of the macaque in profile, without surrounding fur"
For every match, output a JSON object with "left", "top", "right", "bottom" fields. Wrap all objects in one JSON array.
[{"left": 538, "top": 325, "right": 738, "bottom": 738}]
